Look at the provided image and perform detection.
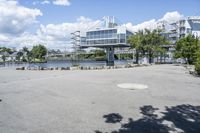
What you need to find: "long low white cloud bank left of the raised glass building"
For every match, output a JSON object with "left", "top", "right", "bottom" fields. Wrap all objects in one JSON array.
[{"left": 0, "top": 16, "right": 102, "bottom": 49}]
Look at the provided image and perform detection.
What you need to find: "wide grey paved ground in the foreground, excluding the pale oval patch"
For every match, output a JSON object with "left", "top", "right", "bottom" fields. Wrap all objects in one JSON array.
[{"left": 0, "top": 65, "right": 200, "bottom": 133}]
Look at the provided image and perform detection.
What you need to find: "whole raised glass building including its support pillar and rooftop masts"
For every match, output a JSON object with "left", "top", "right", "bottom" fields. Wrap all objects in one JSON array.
[{"left": 80, "top": 17, "right": 133, "bottom": 65}]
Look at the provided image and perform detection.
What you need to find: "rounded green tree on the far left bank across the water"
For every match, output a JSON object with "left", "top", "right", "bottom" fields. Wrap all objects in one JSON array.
[{"left": 31, "top": 44, "right": 47, "bottom": 59}]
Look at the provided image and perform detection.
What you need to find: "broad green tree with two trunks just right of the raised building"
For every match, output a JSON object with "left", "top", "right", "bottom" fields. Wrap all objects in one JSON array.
[{"left": 128, "top": 29, "right": 169, "bottom": 63}]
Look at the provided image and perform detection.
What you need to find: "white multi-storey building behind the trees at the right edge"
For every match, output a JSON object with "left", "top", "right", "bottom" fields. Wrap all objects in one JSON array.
[{"left": 157, "top": 16, "right": 200, "bottom": 62}]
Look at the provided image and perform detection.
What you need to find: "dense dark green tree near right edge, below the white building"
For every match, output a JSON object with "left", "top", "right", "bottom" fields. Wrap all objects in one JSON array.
[{"left": 175, "top": 34, "right": 198, "bottom": 64}]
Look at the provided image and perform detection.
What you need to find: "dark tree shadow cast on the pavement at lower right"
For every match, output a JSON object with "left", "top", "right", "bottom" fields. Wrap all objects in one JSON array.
[{"left": 95, "top": 105, "right": 200, "bottom": 133}]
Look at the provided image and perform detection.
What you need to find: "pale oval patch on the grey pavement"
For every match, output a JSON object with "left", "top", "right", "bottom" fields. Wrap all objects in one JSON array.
[{"left": 117, "top": 83, "right": 148, "bottom": 90}]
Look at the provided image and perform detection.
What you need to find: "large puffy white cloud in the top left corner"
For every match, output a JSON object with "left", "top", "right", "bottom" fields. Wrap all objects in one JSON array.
[{"left": 0, "top": 0, "right": 42, "bottom": 34}]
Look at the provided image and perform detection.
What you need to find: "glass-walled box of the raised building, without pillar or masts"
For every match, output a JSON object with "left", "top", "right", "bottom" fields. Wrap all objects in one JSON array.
[{"left": 81, "top": 27, "right": 133, "bottom": 47}]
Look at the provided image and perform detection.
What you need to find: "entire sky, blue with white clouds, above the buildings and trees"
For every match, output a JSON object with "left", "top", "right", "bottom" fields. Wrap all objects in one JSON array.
[{"left": 0, "top": 0, "right": 200, "bottom": 49}]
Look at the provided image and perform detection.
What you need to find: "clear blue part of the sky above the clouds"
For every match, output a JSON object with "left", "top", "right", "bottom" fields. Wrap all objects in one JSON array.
[{"left": 20, "top": 0, "right": 200, "bottom": 24}]
